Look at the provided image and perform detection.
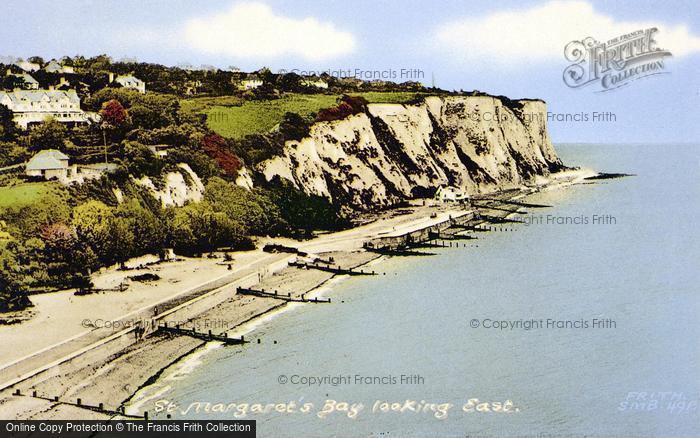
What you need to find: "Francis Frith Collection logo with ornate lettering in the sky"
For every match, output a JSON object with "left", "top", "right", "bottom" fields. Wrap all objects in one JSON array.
[{"left": 564, "top": 27, "right": 671, "bottom": 92}]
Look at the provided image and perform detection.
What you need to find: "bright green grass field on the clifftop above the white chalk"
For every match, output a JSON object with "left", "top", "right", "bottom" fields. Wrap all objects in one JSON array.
[{"left": 181, "top": 92, "right": 426, "bottom": 139}]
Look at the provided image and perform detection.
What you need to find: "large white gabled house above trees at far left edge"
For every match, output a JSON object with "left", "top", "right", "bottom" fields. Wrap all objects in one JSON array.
[{"left": 0, "top": 90, "right": 90, "bottom": 129}]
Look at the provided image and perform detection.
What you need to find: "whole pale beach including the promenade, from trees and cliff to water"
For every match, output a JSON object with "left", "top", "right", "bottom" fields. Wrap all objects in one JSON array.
[{"left": 0, "top": 166, "right": 596, "bottom": 420}]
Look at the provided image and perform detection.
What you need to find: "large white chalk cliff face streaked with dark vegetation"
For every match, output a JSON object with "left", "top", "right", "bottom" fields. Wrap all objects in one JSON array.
[{"left": 258, "top": 96, "right": 562, "bottom": 209}]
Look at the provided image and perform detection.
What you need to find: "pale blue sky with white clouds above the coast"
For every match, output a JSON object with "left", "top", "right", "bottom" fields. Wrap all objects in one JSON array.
[{"left": 0, "top": 0, "right": 700, "bottom": 143}]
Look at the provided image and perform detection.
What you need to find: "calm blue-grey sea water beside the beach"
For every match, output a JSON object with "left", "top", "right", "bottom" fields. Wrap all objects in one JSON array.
[{"left": 133, "top": 145, "right": 700, "bottom": 437}]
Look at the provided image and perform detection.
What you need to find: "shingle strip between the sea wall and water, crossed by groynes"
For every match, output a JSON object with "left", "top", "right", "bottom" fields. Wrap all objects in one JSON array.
[{"left": 0, "top": 166, "right": 590, "bottom": 419}]
